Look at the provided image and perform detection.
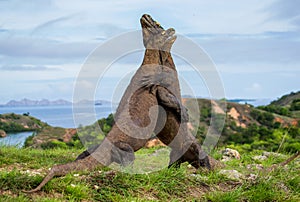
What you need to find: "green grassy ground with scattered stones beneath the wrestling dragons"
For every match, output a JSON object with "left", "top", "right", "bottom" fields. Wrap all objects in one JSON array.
[{"left": 0, "top": 147, "right": 300, "bottom": 201}]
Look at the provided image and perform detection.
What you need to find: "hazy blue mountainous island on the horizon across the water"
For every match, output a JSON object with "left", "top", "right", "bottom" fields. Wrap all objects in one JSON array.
[{"left": 0, "top": 98, "right": 111, "bottom": 107}]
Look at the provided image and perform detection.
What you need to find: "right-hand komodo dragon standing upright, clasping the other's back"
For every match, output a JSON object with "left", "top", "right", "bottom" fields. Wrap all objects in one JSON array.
[{"left": 137, "top": 16, "right": 219, "bottom": 169}]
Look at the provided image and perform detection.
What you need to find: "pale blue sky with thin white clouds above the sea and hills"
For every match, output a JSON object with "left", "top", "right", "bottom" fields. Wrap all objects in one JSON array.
[{"left": 0, "top": 0, "right": 300, "bottom": 104}]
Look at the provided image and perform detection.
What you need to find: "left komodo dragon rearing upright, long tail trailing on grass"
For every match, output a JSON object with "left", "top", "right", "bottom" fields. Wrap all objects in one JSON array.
[{"left": 25, "top": 15, "right": 188, "bottom": 193}]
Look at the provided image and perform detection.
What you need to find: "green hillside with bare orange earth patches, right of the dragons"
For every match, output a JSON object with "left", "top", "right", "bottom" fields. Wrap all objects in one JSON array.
[{"left": 184, "top": 96, "right": 300, "bottom": 152}]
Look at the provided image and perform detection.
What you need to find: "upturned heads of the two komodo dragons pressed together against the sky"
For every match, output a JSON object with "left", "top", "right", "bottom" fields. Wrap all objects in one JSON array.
[{"left": 140, "top": 14, "right": 176, "bottom": 52}]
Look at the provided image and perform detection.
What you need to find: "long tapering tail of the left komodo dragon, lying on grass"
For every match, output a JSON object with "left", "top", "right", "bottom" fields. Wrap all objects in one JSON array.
[{"left": 23, "top": 155, "right": 101, "bottom": 193}]
